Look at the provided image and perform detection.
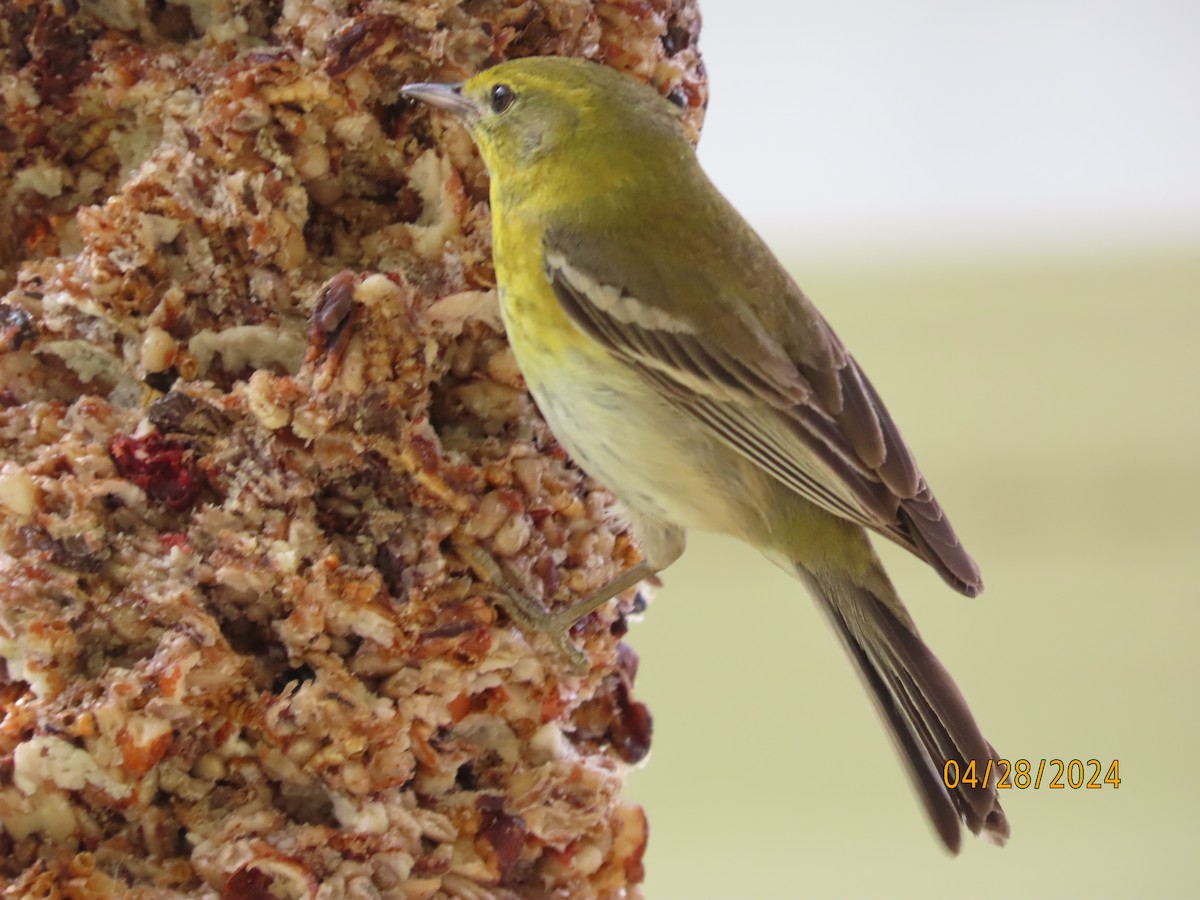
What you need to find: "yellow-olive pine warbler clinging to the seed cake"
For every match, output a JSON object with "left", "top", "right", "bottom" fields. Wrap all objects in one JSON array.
[{"left": 403, "top": 59, "right": 1008, "bottom": 852}]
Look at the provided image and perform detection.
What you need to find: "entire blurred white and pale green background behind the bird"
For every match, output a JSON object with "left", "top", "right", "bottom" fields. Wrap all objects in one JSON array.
[{"left": 629, "top": 0, "right": 1200, "bottom": 900}]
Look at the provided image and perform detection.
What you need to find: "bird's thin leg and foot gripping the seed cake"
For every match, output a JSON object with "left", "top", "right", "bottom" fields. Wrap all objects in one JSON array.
[{"left": 457, "top": 542, "right": 654, "bottom": 672}]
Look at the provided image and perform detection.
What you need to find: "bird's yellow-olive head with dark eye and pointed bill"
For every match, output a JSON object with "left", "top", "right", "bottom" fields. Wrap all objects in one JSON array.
[{"left": 401, "top": 56, "right": 691, "bottom": 202}]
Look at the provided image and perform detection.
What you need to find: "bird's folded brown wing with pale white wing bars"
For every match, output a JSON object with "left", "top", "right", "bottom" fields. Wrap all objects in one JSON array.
[{"left": 544, "top": 226, "right": 983, "bottom": 596}]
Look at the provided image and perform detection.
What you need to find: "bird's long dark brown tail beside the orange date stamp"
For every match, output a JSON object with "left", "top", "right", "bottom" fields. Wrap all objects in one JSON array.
[{"left": 796, "top": 565, "right": 1008, "bottom": 853}]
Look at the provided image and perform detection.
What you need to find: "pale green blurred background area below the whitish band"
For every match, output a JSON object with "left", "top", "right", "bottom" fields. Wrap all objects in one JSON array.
[{"left": 628, "top": 245, "right": 1200, "bottom": 900}]
